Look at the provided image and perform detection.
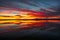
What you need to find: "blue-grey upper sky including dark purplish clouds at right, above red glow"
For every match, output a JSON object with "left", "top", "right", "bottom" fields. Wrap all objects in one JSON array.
[{"left": 0, "top": 0, "right": 60, "bottom": 16}]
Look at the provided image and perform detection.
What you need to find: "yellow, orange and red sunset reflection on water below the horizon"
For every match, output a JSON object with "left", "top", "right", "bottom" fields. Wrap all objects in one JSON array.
[{"left": 0, "top": 20, "right": 60, "bottom": 28}]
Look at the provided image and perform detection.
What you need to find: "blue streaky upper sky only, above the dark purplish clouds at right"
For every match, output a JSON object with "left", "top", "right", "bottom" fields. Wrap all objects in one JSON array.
[{"left": 0, "top": 0, "right": 59, "bottom": 11}]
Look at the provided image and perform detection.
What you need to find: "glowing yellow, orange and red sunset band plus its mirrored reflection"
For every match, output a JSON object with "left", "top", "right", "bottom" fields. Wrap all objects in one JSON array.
[{"left": 0, "top": 6, "right": 60, "bottom": 28}]
